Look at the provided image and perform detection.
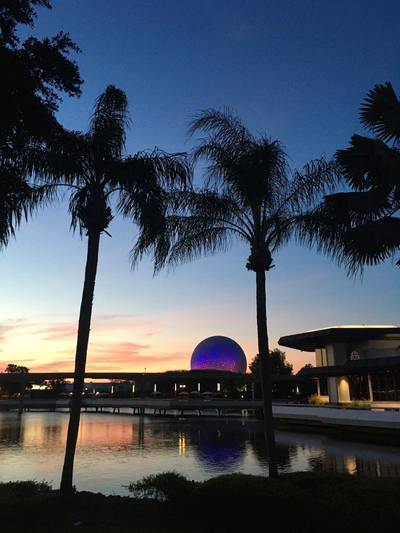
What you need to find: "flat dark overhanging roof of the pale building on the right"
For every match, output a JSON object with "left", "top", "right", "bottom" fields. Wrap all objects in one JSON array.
[{"left": 278, "top": 325, "right": 400, "bottom": 352}]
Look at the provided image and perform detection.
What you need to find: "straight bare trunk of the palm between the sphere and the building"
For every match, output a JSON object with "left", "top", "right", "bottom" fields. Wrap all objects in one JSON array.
[{"left": 256, "top": 270, "right": 278, "bottom": 477}]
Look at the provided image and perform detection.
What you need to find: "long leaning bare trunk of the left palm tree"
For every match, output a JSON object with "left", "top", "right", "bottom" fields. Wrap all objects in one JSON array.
[{"left": 60, "top": 231, "right": 100, "bottom": 496}]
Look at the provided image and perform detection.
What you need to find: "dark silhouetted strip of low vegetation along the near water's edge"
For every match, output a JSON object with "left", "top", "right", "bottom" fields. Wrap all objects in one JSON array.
[{"left": 0, "top": 472, "right": 400, "bottom": 533}]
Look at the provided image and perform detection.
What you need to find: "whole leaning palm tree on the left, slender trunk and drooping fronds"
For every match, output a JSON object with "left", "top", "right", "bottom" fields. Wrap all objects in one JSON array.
[{"left": 33, "top": 85, "right": 190, "bottom": 495}]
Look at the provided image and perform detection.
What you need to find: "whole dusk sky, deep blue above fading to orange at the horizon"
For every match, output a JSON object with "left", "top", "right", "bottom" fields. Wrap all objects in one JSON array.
[{"left": 0, "top": 0, "right": 400, "bottom": 372}]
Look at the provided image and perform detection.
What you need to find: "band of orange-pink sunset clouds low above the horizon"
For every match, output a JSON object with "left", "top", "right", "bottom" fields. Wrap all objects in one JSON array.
[{"left": 0, "top": 312, "right": 314, "bottom": 372}]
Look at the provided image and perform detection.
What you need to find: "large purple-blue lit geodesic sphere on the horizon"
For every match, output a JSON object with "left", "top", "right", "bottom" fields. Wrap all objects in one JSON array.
[{"left": 190, "top": 335, "right": 247, "bottom": 374}]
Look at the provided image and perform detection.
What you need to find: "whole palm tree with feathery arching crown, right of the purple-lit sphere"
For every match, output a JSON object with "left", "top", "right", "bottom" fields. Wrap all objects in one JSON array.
[{"left": 142, "top": 109, "right": 334, "bottom": 475}]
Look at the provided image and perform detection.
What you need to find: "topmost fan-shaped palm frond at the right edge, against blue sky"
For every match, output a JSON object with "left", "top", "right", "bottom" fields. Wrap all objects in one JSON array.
[{"left": 360, "top": 82, "right": 400, "bottom": 143}]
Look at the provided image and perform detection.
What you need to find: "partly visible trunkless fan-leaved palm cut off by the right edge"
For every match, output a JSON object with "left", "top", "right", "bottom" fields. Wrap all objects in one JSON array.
[{"left": 298, "top": 83, "right": 400, "bottom": 274}]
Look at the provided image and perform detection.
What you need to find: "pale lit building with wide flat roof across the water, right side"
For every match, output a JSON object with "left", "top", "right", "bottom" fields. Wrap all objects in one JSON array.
[{"left": 279, "top": 325, "right": 400, "bottom": 403}]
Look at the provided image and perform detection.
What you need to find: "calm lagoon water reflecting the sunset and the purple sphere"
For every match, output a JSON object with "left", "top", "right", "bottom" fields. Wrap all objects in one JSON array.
[{"left": 0, "top": 412, "right": 400, "bottom": 495}]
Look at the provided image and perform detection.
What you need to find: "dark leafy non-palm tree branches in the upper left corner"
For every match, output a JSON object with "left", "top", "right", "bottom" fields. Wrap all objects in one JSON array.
[{"left": 0, "top": 0, "right": 82, "bottom": 248}]
